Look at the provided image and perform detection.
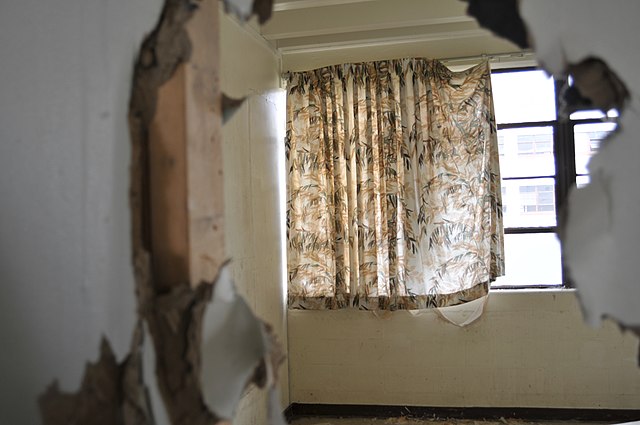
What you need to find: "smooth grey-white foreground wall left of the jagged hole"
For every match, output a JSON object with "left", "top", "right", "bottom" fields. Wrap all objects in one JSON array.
[{"left": 0, "top": 0, "right": 161, "bottom": 425}]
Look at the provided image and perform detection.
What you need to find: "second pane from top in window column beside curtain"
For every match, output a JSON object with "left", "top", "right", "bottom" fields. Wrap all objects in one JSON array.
[{"left": 498, "top": 127, "right": 556, "bottom": 177}]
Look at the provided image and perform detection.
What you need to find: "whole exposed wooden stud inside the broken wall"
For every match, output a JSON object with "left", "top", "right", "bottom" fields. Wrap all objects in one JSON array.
[{"left": 149, "top": 0, "right": 225, "bottom": 289}]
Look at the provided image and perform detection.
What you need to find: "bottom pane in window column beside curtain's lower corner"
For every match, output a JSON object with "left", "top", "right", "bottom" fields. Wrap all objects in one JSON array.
[{"left": 492, "top": 233, "right": 562, "bottom": 287}]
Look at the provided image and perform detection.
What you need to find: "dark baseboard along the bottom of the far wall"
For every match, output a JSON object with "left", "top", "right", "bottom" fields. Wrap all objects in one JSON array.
[{"left": 285, "top": 403, "right": 640, "bottom": 423}]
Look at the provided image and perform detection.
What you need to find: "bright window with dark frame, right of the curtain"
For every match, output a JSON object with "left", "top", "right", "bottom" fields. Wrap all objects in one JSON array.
[{"left": 492, "top": 68, "right": 617, "bottom": 288}]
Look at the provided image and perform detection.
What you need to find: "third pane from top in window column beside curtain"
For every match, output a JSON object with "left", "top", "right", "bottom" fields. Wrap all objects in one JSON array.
[{"left": 502, "top": 178, "right": 556, "bottom": 228}]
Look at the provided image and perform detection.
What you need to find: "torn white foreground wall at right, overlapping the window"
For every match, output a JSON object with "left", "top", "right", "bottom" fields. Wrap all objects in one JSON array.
[{"left": 521, "top": 0, "right": 640, "bottom": 334}]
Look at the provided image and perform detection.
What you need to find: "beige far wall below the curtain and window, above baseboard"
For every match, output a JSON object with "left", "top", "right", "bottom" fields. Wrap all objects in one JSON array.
[{"left": 288, "top": 290, "right": 640, "bottom": 409}]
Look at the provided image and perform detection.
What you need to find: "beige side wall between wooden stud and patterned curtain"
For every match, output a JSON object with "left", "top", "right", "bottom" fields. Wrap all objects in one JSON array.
[{"left": 220, "top": 9, "right": 289, "bottom": 425}]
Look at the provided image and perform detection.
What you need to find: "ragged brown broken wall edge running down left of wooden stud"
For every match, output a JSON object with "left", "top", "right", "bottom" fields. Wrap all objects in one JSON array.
[{"left": 129, "top": 0, "right": 225, "bottom": 425}]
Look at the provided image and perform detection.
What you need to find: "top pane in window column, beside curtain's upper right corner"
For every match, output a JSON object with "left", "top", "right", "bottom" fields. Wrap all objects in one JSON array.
[{"left": 491, "top": 71, "right": 556, "bottom": 124}]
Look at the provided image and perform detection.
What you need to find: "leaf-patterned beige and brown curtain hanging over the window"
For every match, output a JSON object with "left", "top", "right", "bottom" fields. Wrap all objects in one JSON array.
[{"left": 285, "top": 59, "right": 504, "bottom": 310}]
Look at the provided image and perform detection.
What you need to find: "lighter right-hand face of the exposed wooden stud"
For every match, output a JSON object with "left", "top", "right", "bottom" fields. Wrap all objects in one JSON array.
[{"left": 185, "top": 0, "right": 225, "bottom": 285}]
